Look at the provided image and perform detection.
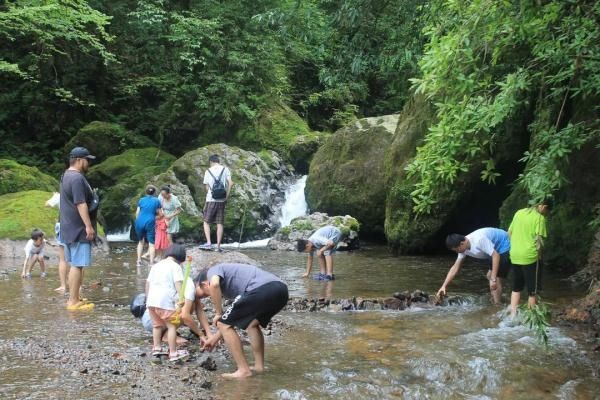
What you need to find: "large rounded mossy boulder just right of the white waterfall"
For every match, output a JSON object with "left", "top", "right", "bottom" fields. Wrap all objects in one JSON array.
[{"left": 306, "top": 114, "right": 398, "bottom": 239}]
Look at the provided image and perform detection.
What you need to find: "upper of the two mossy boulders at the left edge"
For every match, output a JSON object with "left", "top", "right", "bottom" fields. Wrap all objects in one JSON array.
[{"left": 0, "top": 159, "right": 58, "bottom": 196}]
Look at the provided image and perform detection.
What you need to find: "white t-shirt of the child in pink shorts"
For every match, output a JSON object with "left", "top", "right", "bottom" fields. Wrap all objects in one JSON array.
[{"left": 146, "top": 258, "right": 183, "bottom": 310}]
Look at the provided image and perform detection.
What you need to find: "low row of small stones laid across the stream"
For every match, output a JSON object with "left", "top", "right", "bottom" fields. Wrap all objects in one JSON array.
[{"left": 285, "top": 290, "right": 466, "bottom": 312}]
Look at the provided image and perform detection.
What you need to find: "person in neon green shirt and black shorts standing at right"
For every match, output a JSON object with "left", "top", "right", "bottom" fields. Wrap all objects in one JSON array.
[{"left": 508, "top": 199, "right": 551, "bottom": 316}]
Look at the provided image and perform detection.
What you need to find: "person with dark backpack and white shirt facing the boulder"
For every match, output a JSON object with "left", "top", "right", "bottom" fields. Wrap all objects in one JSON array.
[{"left": 200, "top": 154, "right": 233, "bottom": 251}]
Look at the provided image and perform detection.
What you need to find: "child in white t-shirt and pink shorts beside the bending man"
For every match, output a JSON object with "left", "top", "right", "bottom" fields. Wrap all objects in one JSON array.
[{"left": 146, "top": 244, "right": 188, "bottom": 361}]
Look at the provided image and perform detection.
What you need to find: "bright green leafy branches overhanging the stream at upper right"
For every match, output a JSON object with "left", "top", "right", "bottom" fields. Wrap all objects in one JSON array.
[{"left": 408, "top": 0, "right": 600, "bottom": 214}]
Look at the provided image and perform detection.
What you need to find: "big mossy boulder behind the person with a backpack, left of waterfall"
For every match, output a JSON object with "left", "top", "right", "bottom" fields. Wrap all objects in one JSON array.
[{"left": 171, "top": 144, "right": 293, "bottom": 241}]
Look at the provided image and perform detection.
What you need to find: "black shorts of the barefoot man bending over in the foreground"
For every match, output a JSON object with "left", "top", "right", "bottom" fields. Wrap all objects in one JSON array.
[{"left": 219, "top": 281, "right": 288, "bottom": 329}]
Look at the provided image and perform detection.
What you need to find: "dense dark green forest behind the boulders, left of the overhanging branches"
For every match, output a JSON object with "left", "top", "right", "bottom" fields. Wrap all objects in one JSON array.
[{"left": 0, "top": 0, "right": 427, "bottom": 165}]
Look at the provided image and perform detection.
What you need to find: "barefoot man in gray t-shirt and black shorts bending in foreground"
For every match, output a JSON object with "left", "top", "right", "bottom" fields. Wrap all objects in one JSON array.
[{"left": 196, "top": 263, "right": 288, "bottom": 378}]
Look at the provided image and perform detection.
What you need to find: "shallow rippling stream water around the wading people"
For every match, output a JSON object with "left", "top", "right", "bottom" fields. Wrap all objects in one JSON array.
[{"left": 0, "top": 245, "right": 600, "bottom": 400}]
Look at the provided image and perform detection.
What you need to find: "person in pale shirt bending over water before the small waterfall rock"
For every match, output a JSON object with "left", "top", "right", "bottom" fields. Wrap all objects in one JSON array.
[{"left": 296, "top": 225, "right": 342, "bottom": 281}]
